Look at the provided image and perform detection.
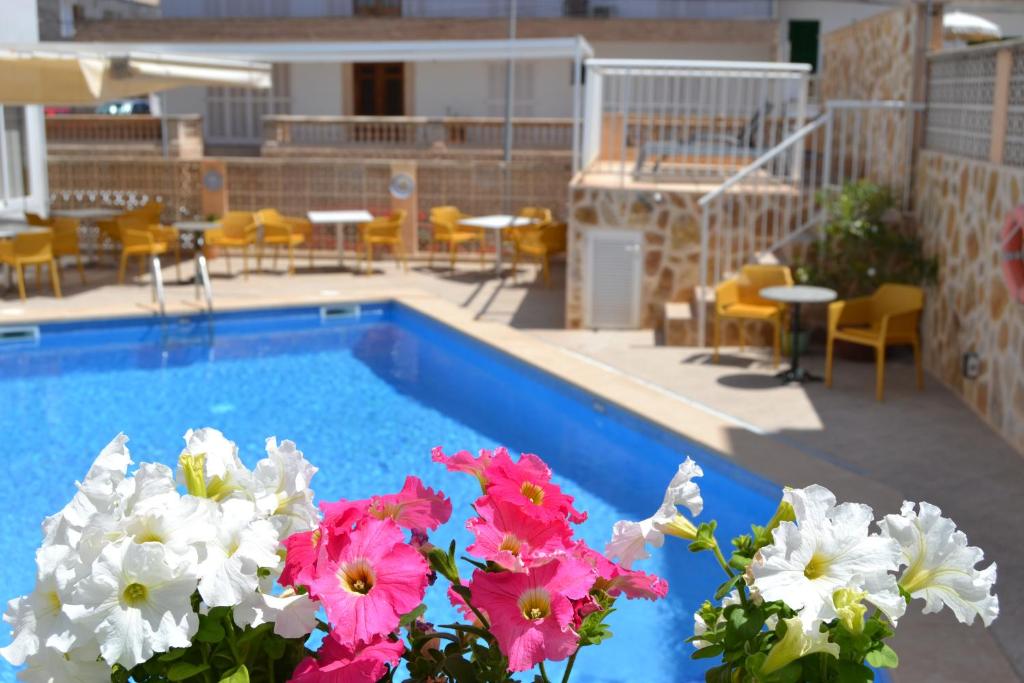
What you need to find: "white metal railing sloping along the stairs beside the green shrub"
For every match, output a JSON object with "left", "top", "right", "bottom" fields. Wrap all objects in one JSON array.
[{"left": 695, "top": 100, "right": 924, "bottom": 346}]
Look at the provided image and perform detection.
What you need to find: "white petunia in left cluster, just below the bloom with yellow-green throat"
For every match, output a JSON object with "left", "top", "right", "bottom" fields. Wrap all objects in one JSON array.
[{"left": 199, "top": 500, "right": 281, "bottom": 607}]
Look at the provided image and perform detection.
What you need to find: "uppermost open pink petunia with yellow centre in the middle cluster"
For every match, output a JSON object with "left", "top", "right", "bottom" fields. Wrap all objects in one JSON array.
[{"left": 484, "top": 451, "right": 587, "bottom": 524}]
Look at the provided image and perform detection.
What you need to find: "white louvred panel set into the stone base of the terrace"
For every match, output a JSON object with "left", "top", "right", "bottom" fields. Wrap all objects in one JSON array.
[{"left": 584, "top": 228, "right": 643, "bottom": 329}]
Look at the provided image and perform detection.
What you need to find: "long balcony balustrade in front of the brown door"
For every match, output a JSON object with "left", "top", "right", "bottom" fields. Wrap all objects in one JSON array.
[{"left": 263, "top": 116, "right": 572, "bottom": 155}]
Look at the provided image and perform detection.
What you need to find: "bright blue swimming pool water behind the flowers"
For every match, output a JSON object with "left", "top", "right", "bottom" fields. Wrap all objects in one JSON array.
[{"left": 0, "top": 304, "right": 777, "bottom": 683}]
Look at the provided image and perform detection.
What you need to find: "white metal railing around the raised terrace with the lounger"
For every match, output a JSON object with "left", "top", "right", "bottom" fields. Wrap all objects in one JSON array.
[{"left": 577, "top": 59, "right": 810, "bottom": 186}]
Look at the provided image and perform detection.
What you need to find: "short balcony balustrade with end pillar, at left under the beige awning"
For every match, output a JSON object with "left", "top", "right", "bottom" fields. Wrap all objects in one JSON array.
[{"left": 46, "top": 114, "right": 203, "bottom": 159}]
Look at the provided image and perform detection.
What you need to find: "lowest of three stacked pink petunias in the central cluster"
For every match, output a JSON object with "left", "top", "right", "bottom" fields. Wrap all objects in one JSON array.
[{"left": 470, "top": 558, "right": 596, "bottom": 672}]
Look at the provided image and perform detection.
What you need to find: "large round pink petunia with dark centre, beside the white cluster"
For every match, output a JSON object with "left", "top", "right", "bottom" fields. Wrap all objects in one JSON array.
[{"left": 309, "top": 518, "right": 429, "bottom": 645}]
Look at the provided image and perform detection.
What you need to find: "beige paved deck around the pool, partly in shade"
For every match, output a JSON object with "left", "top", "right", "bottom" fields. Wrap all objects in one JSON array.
[{"left": 0, "top": 253, "right": 1024, "bottom": 682}]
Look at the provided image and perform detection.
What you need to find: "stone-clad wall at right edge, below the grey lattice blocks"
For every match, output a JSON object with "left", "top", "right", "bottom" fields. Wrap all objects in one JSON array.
[{"left": 916, "top": 151, "right": 1024, "bottom": 453}]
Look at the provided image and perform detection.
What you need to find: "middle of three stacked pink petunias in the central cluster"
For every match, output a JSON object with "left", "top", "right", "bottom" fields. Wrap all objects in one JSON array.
[{"left": 466, "top": 496, "right": 572, "bottom": 571}]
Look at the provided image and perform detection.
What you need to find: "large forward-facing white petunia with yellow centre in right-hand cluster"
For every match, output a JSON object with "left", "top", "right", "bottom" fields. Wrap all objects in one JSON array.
[{"left": 749, "top": 485, "right": 905, "bottom": 633}]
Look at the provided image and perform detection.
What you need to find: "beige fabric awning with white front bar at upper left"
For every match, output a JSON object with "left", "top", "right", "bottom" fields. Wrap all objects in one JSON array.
[{"left": 0, "top": 43, "right": 270, "bottom": 105}]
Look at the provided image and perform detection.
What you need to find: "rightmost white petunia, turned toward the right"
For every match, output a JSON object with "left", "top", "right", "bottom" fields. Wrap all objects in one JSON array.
[{"left": 879, "top": 502, "right": 999, "bottom": 626}]
